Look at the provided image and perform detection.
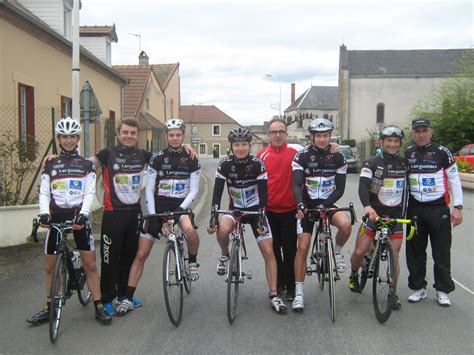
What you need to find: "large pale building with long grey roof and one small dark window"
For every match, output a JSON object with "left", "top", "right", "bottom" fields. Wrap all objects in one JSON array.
[{"left": 339, "top": 44, "right": 466, "bottom": 141}]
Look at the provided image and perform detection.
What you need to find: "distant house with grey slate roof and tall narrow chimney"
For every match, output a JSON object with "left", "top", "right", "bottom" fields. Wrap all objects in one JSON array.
[{"left": 284, "top": 84, "right": 340, "bottom": 143}]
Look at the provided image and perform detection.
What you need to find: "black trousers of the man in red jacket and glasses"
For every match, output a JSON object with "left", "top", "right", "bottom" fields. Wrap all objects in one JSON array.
[{"left": 266, "top": 211, "right": 297, "bottom": 290}]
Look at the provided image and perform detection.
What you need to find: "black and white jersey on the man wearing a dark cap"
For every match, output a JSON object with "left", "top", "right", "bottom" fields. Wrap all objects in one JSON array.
[{"left": 405, "top": 142, "right": 463, "bottom": 206}]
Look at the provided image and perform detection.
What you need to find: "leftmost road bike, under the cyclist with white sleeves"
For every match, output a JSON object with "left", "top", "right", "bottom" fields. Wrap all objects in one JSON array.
[{"left": 32, "top": 218, "right": 91, "bottom": 344}]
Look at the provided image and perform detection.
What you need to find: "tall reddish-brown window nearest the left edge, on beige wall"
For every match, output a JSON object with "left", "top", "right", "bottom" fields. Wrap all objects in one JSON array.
[{"left": 18, "top": 84, "right": 36, "bottom": 160}]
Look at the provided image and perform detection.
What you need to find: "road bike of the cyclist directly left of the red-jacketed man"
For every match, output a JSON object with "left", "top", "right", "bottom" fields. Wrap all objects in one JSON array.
[{"left": 210, "top": 208, "right": 265, "bottom": 324}]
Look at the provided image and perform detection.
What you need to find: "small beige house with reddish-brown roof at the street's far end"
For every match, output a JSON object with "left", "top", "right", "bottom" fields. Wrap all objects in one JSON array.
[{"left": 179, "top": 105, "right": 243, "bottom": 158}]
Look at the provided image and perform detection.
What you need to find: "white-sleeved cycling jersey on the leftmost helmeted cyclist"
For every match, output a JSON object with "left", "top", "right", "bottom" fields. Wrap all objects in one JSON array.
[{"left": 39, "top": 151, "right": 96, "bottom": 215}]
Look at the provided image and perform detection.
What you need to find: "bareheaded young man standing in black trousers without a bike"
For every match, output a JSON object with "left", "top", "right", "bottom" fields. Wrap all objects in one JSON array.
[{"left": 91, "top": 118, "right": 152, "bottom": 315}]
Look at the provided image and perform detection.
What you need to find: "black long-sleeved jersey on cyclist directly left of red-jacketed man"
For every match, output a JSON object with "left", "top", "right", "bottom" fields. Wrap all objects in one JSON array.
[{"left": 212, "top": 155, "right": 268, "bottom": 209}]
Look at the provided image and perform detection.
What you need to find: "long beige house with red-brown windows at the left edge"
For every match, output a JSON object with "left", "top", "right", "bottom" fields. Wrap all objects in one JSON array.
[{"left": 0, "top": 0, "right": 127, "bottom": 203}]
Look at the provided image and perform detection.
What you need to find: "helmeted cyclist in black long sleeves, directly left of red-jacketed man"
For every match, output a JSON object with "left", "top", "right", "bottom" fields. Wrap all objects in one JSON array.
[{"left": 208, "top": 127, "right": 286, "bottom": 313}]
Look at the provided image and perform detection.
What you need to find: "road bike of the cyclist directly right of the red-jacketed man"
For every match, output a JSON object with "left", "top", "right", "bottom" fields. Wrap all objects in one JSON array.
[{"left": 306, "top": 203, "right": 356, "bottom": 322}]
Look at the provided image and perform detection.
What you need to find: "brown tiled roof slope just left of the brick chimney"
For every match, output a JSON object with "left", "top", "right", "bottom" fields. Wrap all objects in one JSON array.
[{"left": 113, "top": 65, "right": 151, "bottom": 118}]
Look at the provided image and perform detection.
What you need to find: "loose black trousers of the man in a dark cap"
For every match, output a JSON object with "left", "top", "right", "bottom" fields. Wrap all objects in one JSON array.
[{"left": 406, "top": 203, "right": 455, "bottom": 293}]
